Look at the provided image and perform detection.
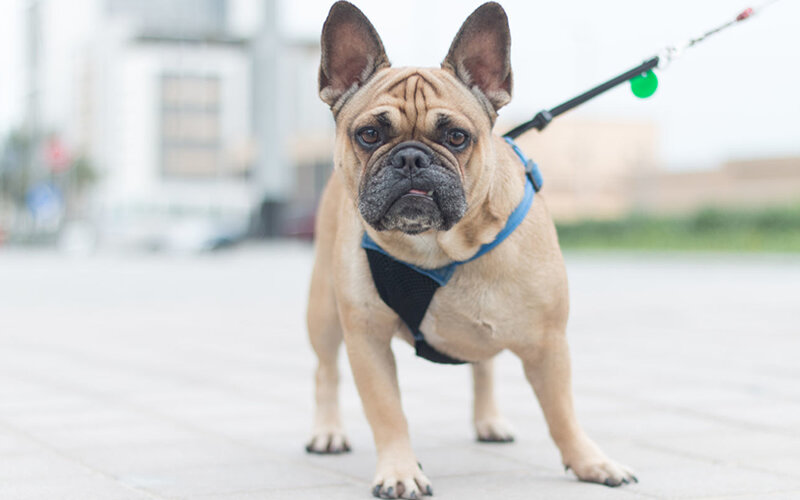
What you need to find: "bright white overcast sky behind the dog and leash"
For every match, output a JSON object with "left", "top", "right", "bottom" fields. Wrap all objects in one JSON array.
[{"left": 0, "top": 0, "right": 800, "bottom": 169}]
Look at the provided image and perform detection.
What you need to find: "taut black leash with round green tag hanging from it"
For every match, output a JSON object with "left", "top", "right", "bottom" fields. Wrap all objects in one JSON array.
[{"left": 504, "top": 0, "right": 778, "bottom": 139}]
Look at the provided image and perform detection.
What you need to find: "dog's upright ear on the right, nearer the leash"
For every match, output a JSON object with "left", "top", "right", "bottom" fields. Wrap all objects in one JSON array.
[{"left": 442, "top": 2, "right": 512, "bottom": 111}]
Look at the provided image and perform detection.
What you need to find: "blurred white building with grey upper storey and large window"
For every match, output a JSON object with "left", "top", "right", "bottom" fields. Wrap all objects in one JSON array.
[{"left": 83, "top": 0, "right": 259, "bottom": 247}]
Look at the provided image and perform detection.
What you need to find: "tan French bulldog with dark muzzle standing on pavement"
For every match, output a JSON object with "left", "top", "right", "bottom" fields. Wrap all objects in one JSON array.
[{"left": 306, "top": 1, "right": 636, "bottom": 498}]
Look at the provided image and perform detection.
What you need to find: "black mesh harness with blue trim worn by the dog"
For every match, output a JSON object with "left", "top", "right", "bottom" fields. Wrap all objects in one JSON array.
[{"left": 361, "top": 137, "right": 542, "bottom": 364}]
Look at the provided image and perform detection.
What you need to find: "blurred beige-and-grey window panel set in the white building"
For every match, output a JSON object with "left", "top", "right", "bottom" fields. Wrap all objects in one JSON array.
[{"left": 161, "top": 75, "right": 221, "bottom": 177}]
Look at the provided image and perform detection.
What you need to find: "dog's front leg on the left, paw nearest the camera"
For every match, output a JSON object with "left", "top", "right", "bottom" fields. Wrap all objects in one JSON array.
[{"left": 345, "top": 322, "right": 432, "bottom": 498}]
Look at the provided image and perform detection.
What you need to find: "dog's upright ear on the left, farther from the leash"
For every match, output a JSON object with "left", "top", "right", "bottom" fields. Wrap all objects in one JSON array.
[{"left": 319, "top": 1, "right": 389, "bottom": 107}]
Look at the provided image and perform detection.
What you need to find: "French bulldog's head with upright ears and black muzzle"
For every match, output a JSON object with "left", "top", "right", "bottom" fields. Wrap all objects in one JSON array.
[{"left": 319, "top": 2, "right": 512, "bottom": 234}]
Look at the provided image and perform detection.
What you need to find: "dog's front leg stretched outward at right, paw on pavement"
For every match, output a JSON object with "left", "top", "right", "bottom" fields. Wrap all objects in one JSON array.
[{"left": 518, "top": 332, "right": 636, "bottom": 486}]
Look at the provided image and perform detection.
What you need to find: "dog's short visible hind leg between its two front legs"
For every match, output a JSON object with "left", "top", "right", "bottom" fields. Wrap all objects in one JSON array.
[{"left": 472, "top": 359, "right": 514, "bottom": 443}]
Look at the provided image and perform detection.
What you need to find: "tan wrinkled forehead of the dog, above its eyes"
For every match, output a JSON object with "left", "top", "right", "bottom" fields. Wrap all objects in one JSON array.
[{"left": 336, "top": 68, "right": 494, "bottom": 139}]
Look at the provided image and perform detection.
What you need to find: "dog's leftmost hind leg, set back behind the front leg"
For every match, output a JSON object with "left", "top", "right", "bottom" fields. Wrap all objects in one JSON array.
[{"left": 306, "top": 255, "right": 350, "bottom": 453}]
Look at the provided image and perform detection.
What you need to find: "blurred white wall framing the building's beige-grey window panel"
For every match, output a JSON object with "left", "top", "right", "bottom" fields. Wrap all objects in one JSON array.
[{"left": 89, "top": 33, "right": 253, "bottom": 213}]
